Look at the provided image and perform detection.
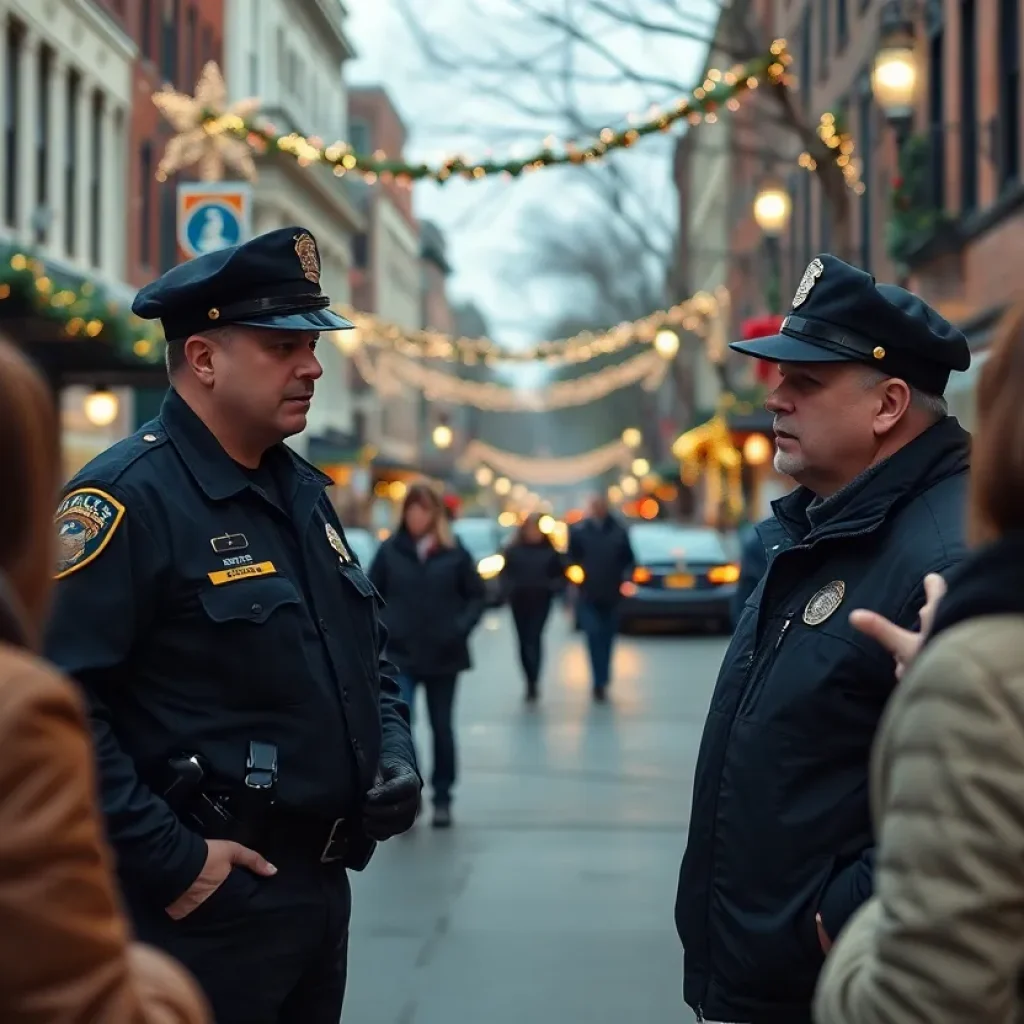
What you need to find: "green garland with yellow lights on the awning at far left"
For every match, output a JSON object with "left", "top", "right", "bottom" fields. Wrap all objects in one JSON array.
[{"left": 0, "top": 246, "right": 164, "bottom": 364}]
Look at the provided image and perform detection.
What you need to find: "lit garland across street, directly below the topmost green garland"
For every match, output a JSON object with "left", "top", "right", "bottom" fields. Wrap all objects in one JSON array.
[{"left": 336, "top": 289, "right": 727, "bottom": 366}]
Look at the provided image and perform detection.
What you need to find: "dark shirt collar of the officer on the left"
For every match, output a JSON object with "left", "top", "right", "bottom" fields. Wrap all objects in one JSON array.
[{"left": 160, "top": 388, "right": 332, "bottom": 501}]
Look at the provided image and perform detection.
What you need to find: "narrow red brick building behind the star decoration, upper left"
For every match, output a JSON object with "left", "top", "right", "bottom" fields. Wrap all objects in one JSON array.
[{"left": 112, "top": 0, "right": 224, "bottom": 286}]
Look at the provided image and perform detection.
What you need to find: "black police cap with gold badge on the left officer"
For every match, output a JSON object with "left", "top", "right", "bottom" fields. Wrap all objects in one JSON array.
[{"left": 131, "top": 227, "right": 354, "bottom": 341}]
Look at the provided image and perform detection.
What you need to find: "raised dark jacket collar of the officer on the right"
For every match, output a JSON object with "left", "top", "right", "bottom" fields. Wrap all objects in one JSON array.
[{"left": 772, "top": 416, "right": 971, "bottom": 544}]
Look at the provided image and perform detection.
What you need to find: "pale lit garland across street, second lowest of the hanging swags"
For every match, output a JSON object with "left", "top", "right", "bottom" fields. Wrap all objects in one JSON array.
[{"left": 350, "top": 348, "right": 669, "bottom": 413}]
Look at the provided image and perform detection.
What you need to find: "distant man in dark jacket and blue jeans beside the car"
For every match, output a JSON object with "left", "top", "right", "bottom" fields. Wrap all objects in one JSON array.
[{"left": 568, "top": 495, "right": 636, "bottom": 701}]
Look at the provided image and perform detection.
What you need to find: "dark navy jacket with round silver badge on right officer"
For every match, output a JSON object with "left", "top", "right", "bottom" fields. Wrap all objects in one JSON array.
[{"left": 676, "top": 418, "right": 970, "bottom": 1024}]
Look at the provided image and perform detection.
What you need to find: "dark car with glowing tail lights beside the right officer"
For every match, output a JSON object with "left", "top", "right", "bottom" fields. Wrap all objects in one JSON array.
[{"left": 622, "top": 522, "right": 739, "bottom": 632}]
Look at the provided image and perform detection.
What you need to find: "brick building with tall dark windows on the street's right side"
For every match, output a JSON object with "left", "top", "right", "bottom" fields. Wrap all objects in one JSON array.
[{"left": 677, "top": 0, "right": 1024, "bottom": 423}]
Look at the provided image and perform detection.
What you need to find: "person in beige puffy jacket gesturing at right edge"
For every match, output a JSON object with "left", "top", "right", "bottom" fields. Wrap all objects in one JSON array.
[{"left": 814, "top": 304, "right": 1024, "bottom": 1024}]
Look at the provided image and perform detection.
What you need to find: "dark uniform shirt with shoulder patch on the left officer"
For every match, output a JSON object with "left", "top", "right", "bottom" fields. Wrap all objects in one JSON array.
[{"left": 46, "top": 390, "right": 415, "bottom": 905}]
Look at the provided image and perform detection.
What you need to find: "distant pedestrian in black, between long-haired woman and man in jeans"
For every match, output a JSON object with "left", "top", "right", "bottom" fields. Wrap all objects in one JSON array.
[{"left": 501, "top": 513, "right": 565, "bottom": 702}]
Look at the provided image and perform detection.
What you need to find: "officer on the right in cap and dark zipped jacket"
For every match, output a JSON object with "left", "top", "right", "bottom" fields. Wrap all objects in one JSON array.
[{"left": 676, "top": 249, "right": 970, "bottom": 1024}]
